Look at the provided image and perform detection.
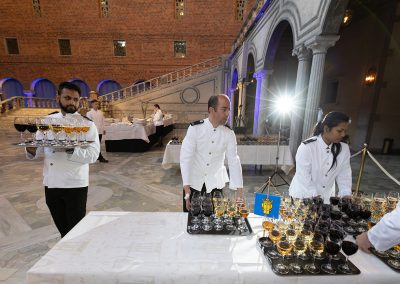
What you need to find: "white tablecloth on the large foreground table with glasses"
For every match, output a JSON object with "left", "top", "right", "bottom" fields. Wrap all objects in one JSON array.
[{"left": 27, "top": 212, "right": 400, "bottom": 284}]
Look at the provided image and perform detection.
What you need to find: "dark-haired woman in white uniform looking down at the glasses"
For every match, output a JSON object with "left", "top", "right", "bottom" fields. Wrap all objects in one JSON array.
[{"left": 289, "top": 112, "right": 352, "bottom": 203}]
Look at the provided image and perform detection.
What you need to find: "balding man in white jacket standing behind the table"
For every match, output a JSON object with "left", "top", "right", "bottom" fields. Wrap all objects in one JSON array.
[{"left": 180, "top": 94, "right": 243, "bottom": 212}]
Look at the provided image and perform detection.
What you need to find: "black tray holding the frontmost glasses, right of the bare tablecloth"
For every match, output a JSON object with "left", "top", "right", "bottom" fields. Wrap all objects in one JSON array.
[{"left": 257, "top": 237, "right": 361, "bottom": 276}]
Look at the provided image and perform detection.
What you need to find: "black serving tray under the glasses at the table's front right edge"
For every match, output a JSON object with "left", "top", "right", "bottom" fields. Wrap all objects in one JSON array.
[{"left": 257, "top": 237, "right": 361, "bottom": 276}]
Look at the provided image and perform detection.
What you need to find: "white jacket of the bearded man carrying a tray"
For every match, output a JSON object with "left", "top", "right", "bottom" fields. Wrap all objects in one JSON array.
[{"left": 26, "top": 113, "right": 100, "bottom": 188}]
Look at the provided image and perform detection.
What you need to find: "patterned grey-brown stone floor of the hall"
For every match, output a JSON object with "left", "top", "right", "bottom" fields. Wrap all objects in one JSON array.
[{"left": 0, "top": 131, "right": 400, "bottom": 283}]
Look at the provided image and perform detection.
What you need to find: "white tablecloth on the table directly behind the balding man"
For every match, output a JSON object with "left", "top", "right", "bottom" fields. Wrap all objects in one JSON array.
[{"left": 162, "top": 143, "right": 294, "bottom": 174}]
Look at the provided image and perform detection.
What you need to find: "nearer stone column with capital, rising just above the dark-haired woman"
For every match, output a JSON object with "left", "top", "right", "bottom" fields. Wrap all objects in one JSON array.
[{"left": 302, "top": 36, "right": 339, "bottom": 139}]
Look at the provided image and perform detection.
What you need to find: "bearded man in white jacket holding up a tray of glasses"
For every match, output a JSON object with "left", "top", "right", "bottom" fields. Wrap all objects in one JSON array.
[{"left": 26, "top": 82, "right": 100, "bottom": 237}]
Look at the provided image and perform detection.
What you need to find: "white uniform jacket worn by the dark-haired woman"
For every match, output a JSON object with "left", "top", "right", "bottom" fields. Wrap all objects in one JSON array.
[{"left": 289, "top": 135, "right": 352, "bottom": 203}]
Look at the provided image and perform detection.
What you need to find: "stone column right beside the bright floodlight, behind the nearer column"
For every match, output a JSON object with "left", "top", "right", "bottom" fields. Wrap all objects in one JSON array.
[{"left": 289, "top": 44, "right": 311, "bottom": 157}]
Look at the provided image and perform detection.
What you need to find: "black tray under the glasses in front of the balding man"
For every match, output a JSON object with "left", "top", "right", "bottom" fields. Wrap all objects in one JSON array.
[{"left": 187, "top": 214, "right": 253, "bottom": 236}]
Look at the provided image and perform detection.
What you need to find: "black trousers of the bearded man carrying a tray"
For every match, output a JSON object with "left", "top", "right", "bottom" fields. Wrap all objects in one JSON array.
[{"left": 44, "top": 186, "right": 88, "bottom": 237}]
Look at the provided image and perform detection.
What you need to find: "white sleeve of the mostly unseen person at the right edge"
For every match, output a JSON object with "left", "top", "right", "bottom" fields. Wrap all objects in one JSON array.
[{"left": 368, "top": 202, "right": 400, "bottom": 251}]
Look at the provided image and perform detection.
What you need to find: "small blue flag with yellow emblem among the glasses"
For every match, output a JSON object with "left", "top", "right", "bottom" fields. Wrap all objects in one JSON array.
[{"left": 254, "top": 192, "right": 281, "bottom": 219}]
